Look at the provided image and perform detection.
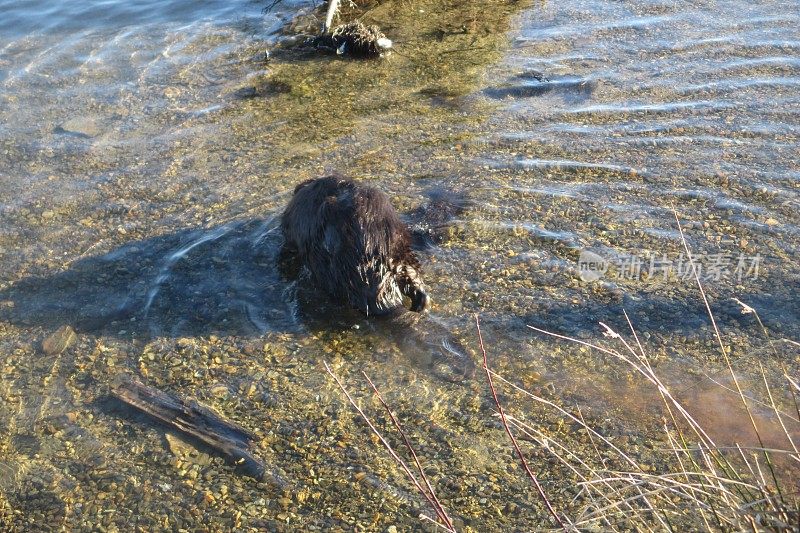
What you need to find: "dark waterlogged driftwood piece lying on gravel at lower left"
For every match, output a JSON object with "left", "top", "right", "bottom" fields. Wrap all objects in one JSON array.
[{"left": 111, "top": 376, "right": 265, "bottom": 479}]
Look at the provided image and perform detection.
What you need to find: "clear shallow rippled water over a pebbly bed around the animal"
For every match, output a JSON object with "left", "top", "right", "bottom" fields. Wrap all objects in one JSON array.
[{"left": 0, "top": 0, "right": 800, "bottom": 531}]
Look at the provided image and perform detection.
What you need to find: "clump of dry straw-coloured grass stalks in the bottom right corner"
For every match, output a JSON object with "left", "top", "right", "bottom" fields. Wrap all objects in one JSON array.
[{"left": 487, "top": 213, "right": 800, "bottom": 531}]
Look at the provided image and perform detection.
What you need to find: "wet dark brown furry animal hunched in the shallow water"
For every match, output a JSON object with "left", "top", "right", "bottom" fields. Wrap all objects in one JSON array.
[{"left": 281, "top": 176, "right": 429, "bottom": 315}]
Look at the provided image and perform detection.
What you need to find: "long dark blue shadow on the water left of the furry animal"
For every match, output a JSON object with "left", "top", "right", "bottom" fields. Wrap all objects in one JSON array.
[{"left": 0, "top": 218, "right": 300, "bottom": 338}]
